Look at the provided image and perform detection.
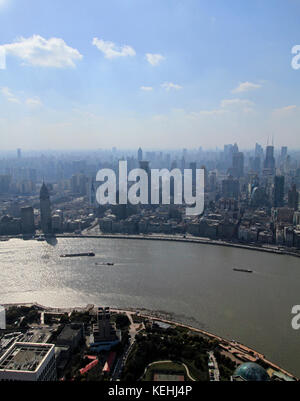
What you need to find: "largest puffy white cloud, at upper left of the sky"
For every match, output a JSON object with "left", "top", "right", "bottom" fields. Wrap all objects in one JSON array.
[{"left": 0, "top": 35, "right": 83, "bottom": 68}]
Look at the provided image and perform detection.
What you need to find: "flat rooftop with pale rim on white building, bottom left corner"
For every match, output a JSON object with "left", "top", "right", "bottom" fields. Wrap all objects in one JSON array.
[{"left": 0, "top": 343, "right": 54, "bottom": 372}]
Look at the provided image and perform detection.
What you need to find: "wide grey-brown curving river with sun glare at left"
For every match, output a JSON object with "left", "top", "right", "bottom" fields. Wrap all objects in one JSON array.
[{"left": 0, "top": 238, "right": 300, "bottom": 377}]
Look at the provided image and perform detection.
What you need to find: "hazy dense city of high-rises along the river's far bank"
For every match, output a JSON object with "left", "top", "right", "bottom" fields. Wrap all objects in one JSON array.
[{"left": 0, "top": 144, "right": 300, "bottom": 253}]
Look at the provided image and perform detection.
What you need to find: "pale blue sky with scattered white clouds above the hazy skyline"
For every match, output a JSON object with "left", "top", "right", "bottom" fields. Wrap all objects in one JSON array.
[{"left": 0, "top": 0, "right": 300, "bottom": 150}]
